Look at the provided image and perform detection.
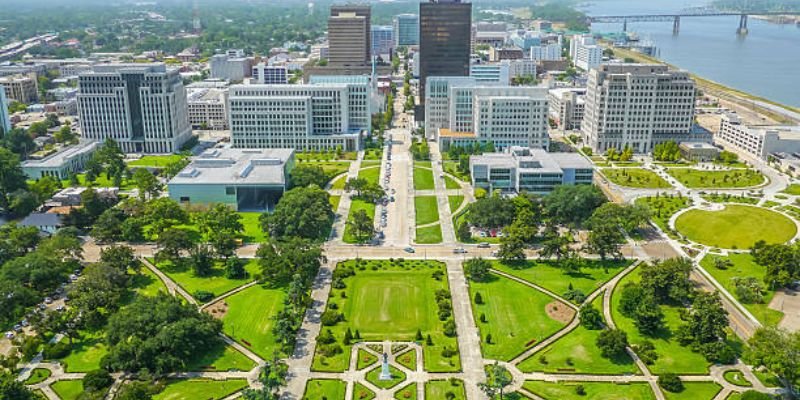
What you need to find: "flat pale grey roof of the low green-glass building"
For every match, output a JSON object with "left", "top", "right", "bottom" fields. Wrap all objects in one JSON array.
[{"left": 169, "top": 149, "right": 294, "bottom": 185}]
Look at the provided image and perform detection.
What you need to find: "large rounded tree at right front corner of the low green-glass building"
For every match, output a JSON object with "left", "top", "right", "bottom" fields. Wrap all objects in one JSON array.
[{"left": 260, "top": 185, "right": 335, "bottom": 240}]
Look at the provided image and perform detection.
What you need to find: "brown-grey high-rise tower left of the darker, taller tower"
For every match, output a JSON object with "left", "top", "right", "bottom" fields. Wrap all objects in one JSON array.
[{"left": 328, "top": 5, "right": 372, "bottom": 67}]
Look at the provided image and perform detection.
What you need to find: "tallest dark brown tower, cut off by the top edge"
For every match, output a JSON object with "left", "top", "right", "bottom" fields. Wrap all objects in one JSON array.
[{"left": 416, "top": 0, "right": 472, "bottom": 114}]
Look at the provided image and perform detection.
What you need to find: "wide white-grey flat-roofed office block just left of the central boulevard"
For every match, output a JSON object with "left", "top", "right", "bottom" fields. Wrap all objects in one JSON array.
[{"left": 229, "top": 75, "right": 373, "bottom": 151}]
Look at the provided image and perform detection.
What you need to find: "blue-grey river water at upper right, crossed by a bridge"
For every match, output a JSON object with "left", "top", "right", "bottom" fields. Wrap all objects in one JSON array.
[{"left": 583, "top": 0, "right": 800, "bottom": 107}]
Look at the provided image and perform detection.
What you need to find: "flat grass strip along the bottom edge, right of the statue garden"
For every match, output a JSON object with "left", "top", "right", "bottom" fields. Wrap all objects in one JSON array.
[{"left": 522, "top": 381, "right": 655, "bottom": 400}]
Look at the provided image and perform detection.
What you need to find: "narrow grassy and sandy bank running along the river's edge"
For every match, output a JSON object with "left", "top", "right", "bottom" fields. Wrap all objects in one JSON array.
[{"left": 602, "top": 43, "right": 800, "bottom": 124}]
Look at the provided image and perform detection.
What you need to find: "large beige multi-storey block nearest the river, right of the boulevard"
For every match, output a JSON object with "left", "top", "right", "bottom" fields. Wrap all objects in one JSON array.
[{"left": 581, "top": 64, "right": 711, "bottom": 153}]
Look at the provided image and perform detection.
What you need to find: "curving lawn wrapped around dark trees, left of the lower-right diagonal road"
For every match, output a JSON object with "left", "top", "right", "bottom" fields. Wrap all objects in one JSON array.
[{"left": 611, "top": 268, "right": 709, "bottom": 374}]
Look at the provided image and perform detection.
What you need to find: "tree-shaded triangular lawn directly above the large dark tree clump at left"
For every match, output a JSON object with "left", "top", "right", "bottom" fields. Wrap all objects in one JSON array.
[{"left": 150, "top": 259, "right": 260, "bottom": 297}]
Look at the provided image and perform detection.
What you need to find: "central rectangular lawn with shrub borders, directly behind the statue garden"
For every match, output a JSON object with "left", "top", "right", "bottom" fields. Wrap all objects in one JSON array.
[{"left": 313, "top": 260, "right": 461, "bottom": 372}]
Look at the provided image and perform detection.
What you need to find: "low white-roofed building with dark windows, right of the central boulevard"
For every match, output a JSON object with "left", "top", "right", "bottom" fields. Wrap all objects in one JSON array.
[{"left": 469, "top": 147, "right": 594, "bottom": 194}]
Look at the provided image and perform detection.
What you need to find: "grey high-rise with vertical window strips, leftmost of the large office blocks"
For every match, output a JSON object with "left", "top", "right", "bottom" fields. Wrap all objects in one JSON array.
[{"left": 78, "top": 63, "right": 192, "bottom": 153}]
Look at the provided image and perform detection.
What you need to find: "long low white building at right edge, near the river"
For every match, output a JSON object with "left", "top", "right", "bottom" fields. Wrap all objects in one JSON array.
[{"left": 714, "top": 114, "right": 800, "bottom": 160}]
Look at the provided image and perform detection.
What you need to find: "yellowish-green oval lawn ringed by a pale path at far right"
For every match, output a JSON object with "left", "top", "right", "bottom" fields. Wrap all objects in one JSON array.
[{"left": 675, "top": 204, "right": 797, "bottom": 249}]
